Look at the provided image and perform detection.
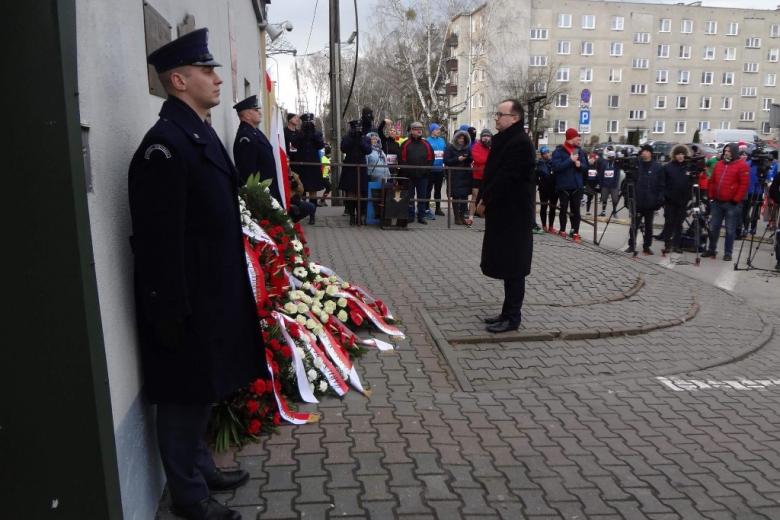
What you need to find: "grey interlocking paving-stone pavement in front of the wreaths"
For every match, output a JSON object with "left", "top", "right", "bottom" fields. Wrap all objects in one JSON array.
[{"left": 158, "top": 208, "right": 780, "bottom": 520}]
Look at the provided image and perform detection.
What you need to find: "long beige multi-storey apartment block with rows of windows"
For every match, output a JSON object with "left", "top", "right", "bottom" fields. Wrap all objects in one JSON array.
[{"left": 447, "top": 0, "right": 780, "bottom": 144}]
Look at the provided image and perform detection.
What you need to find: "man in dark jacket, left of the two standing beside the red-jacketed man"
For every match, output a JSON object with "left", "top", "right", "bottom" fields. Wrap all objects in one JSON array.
[{"left": 626, "top": 144, "right": 666, "bottom": 255}]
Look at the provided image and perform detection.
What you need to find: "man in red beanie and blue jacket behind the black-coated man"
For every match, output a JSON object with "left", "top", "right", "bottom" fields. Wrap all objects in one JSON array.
[{"left": 551, "top": 128, "right": 588, "bottom": 242}]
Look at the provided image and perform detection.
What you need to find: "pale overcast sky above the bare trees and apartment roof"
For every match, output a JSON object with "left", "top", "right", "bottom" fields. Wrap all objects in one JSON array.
[{"left": 268, "top": 0, "right": 780, "bottom": 109}]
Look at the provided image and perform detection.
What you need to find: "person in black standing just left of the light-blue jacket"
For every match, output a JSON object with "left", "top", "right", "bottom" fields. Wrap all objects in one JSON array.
[{"left": 339, "top": 119, "right": 372, "bottom": 226}]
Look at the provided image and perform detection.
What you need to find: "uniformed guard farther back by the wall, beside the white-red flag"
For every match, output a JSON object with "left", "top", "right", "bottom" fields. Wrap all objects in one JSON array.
[{"left": 233, "top": 96, "right": 282, "bottom": 199}]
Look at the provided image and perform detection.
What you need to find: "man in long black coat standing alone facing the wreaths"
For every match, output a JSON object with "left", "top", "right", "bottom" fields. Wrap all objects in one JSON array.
[{"left": 477, "top": 99, "right": 536, "bottom": 333}]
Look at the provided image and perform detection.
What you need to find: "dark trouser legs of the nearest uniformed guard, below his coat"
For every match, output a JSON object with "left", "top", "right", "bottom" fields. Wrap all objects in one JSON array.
[{"left": 157, "top": 404, "right": 217, "bottom": 505}]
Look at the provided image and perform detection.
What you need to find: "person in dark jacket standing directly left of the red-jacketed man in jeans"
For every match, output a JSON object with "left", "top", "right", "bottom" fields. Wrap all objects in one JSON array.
[{"left": 663, "top": 144, "right": 691, "bottom": 253}]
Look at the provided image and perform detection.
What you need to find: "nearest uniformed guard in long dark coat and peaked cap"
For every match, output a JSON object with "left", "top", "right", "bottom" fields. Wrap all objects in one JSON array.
[{"left": 129, "top": 29, "right": 266, "bottom": 520}]
